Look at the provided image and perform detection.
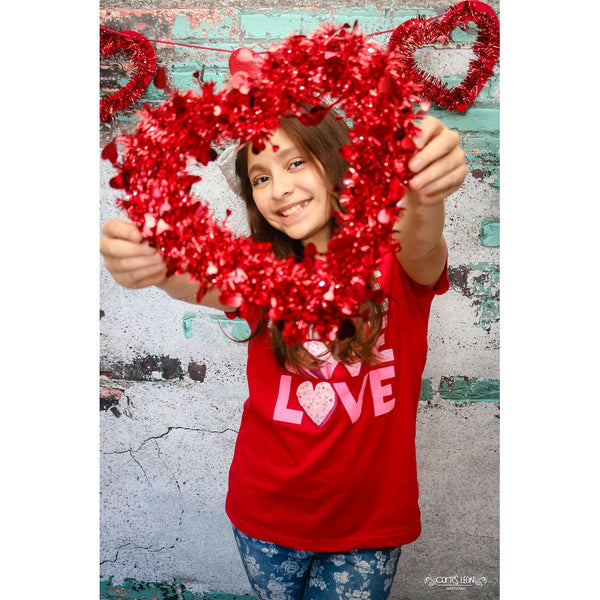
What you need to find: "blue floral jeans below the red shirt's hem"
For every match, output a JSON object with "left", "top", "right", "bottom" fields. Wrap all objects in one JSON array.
[{"left": 233, "top": 527, "right": 400, "bottom": 600}]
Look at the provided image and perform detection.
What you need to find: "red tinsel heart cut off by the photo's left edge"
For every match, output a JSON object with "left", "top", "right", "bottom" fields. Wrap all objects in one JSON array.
[{"left": 100, "top": 27, "right": 156, "bottom": 123}]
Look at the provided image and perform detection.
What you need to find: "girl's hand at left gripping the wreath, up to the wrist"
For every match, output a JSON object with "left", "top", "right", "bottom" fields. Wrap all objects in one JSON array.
[{"left": 100, "top": 219, "right": 167, "bottom": 289}]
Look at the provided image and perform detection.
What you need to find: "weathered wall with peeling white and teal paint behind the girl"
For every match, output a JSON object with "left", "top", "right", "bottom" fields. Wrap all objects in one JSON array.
[{"left": 99, "top": 0, "right": 500, "bottom": 600}]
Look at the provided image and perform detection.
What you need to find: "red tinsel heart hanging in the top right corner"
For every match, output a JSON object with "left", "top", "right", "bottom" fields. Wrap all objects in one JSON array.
[{"left": 388, "top": 0, "right": 500, "bottom": 112}]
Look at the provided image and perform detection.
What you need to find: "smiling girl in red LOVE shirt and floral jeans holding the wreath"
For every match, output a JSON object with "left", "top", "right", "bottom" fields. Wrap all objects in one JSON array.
[{"left": 100, "top": 112, "right": 466, "bottom": 600}]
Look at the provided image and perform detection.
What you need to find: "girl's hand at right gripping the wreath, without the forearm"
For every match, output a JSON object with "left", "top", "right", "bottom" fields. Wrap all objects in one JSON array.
[{"left": 407, "top": 116, "right": 467, "bottom": 205}]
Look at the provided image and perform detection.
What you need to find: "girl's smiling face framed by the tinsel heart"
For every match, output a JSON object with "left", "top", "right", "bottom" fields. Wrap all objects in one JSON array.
[{"left": 247, "top": 129, "right": 333, "bottom": 252}]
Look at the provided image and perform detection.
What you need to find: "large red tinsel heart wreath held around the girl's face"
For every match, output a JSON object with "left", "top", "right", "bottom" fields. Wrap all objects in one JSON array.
[{"left": 103, "top": 24, "right": 423, "bottom": 343}]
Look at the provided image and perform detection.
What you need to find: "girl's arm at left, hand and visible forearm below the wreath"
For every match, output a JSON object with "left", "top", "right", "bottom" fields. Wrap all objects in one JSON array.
[{"left": 100, "top": 219, "right": 234, "bottom": 311}]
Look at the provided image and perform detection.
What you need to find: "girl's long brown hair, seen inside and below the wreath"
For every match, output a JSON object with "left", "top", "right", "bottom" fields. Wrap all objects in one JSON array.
[{"left": 236, "top": 110, "right": 383, "bottom": 369}]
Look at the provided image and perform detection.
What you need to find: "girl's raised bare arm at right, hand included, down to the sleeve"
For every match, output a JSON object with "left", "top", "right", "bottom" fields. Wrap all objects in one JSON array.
[{"left": 394, "top": 116, "right": 467, "bottom": 287}]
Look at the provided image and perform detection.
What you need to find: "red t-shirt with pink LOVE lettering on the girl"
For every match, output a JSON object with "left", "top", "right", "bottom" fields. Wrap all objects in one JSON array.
[{"left": 226, "top": 253, "right": 449, "bottom": 552}]
